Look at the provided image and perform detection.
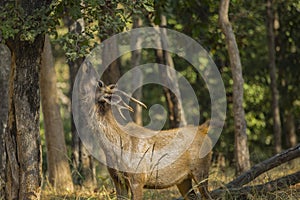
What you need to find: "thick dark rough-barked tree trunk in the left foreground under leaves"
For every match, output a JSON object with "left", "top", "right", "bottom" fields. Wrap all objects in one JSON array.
[{"left": 5, "top": 35, "right": 44, "bottom": 199}]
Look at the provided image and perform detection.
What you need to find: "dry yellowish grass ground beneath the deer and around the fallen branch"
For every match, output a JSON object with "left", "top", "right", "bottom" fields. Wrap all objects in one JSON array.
[{"left": 42, "top": 158, "right": 300, "bottom": 200}]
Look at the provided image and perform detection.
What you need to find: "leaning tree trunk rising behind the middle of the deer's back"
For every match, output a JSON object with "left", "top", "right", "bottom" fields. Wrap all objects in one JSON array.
[{"left": 156, "top": 15, "right": 187, "bottom": 128}]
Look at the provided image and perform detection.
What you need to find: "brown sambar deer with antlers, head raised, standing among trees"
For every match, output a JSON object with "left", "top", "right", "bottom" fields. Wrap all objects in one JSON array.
[{"left": 94, "top": 81, "right": 211, "bottom": 200}]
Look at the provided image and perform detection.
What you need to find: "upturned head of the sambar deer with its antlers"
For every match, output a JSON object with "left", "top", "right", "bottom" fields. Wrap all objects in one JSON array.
[{"left": 95, "top": 80, "right": 147, "bottom": 118}]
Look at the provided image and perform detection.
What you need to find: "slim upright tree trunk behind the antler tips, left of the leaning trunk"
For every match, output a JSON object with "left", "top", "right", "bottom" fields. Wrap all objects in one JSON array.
[{"left": 131, "top": 17, "right": 143, "bottom": 126}]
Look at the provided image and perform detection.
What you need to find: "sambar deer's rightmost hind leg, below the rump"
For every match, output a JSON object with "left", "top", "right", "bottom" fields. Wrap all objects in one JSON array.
[{"left": 192, "top": 171, "right": 212, "bottom": 199}]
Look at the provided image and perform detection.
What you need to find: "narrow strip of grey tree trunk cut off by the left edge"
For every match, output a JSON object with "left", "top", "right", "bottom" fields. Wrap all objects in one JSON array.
[{"left": 0, "top": 44, "right": 11, "bottom": 199}]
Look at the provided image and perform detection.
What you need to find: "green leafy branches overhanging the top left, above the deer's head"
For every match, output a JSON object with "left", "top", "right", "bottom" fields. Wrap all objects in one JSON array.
[{"left": 0, "top": 0, "right": 153, "bottom": 60}]
